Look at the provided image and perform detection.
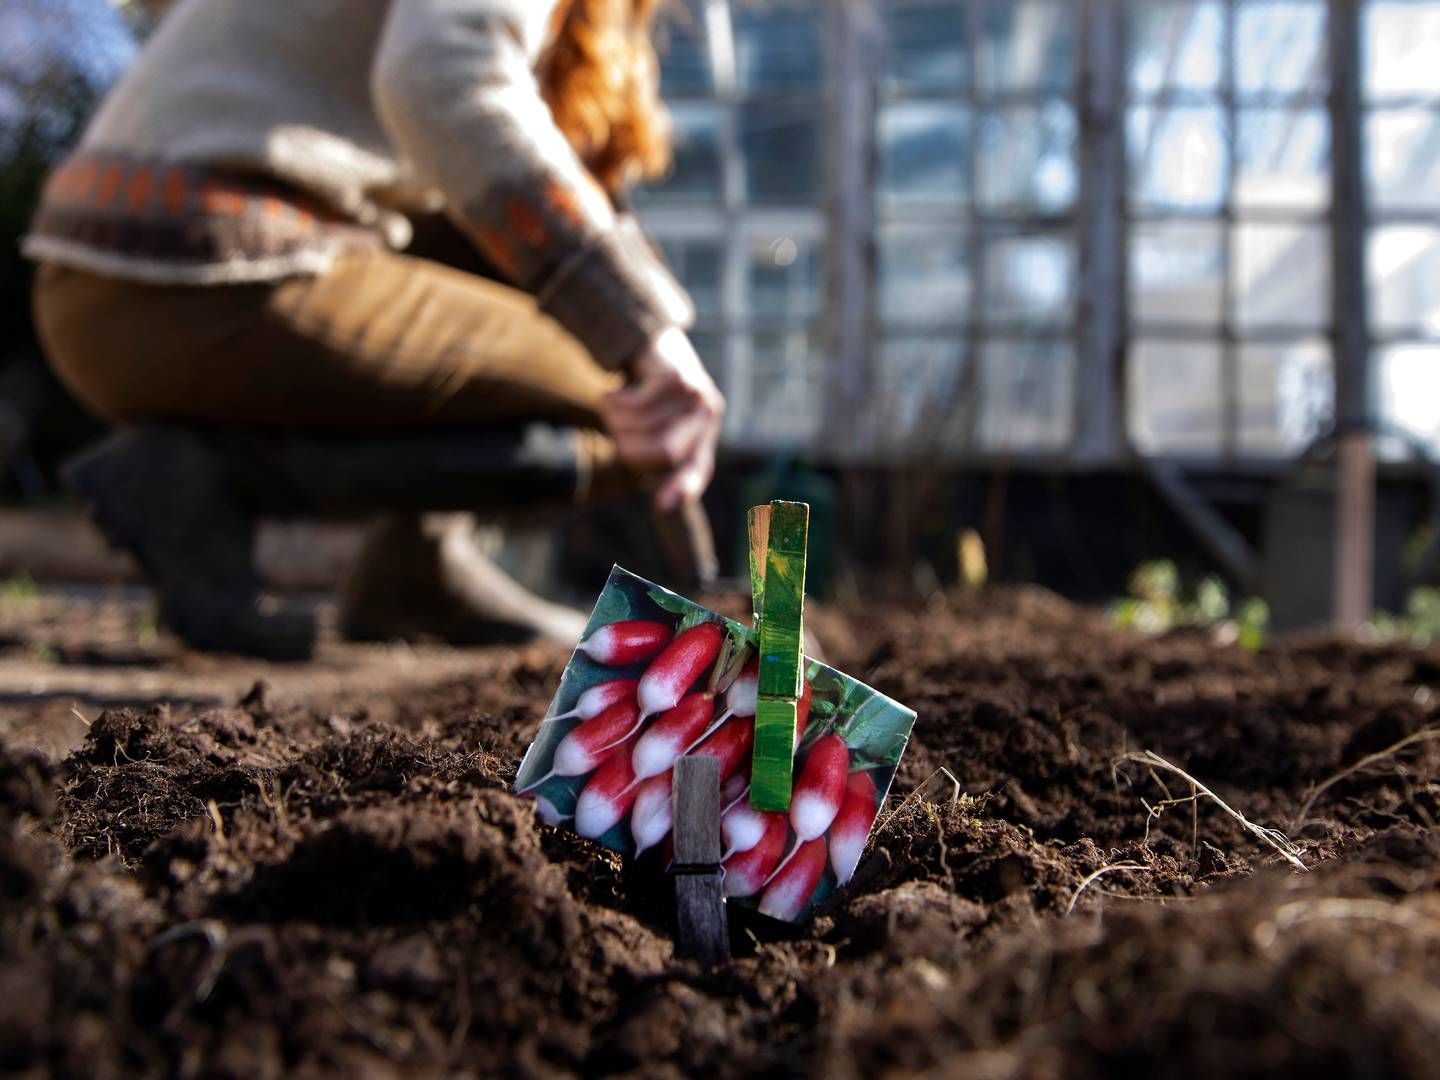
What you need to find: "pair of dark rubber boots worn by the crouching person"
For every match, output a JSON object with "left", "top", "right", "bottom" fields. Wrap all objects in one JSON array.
[{"left": 66, "top": 425, "right": 583, "bottom": 660}]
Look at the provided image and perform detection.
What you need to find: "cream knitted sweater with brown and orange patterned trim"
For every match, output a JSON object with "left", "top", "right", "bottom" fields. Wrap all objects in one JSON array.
[{"left": 26, "top": 0, "right": 691, "bottom": 367}]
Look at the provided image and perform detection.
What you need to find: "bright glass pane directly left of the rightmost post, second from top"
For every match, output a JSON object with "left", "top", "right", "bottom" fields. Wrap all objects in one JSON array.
[{"left": 1236, "top": 109, "right": 1331, "bottom": 210}]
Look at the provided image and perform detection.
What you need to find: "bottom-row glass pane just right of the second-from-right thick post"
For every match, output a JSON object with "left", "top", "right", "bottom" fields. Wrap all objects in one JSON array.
[{"left": 1129, "top": 340, "right": 1224, "bottom": 455}]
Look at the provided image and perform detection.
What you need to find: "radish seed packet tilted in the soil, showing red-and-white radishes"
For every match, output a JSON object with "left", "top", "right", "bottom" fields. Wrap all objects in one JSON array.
[{"left": 516, "top": 566, "right": 914, "bottom": 922}]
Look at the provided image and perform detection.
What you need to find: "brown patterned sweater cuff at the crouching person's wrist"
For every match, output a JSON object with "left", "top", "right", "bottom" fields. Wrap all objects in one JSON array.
[{"left": 536, "top": 215, "right": 696, "bottom": 370}]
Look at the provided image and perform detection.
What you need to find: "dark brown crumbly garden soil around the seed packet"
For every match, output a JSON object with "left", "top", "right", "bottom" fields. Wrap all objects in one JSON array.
[{"left": 0, "top": 592, "right": 1440, "bottom": 1077}]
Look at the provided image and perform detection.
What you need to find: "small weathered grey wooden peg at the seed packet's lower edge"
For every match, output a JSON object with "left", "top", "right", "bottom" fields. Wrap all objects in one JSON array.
[{"left": 672, "top": 755, "right": 730, "bottom": 966}]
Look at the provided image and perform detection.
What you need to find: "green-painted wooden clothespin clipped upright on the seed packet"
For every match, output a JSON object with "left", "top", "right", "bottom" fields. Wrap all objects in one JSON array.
[{"left": 749, "top": 503, "right": 809, "bottom": 811}]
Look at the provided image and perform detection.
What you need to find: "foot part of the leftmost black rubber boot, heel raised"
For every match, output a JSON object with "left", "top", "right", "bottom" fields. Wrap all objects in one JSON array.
[{"left": 65, "top": 428, "right": 315, "bottom": 660}]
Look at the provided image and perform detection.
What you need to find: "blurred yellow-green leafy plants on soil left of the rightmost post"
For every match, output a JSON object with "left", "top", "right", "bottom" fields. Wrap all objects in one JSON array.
[{"left": 1109, "top": 559, "right": 1267, "bottom": 652}]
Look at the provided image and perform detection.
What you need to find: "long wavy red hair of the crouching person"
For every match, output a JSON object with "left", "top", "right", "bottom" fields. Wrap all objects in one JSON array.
[{"left": 539, "top": 0, "right": 670, "bottom": 194}]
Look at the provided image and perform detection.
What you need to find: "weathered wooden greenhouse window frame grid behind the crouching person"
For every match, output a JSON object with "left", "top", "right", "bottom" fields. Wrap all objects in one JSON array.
[{"left": 645, "top": 0, "right": 1405, "bottom": 472}]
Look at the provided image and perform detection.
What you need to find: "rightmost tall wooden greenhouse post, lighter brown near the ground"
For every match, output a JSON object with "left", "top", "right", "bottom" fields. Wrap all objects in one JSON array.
[{"left": 1329, "top": 0, "right": 1375, "bottom": 632}]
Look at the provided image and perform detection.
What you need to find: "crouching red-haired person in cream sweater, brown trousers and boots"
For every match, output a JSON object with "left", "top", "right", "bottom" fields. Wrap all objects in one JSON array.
[{"left": 26, "top": 0, "right": 723, "bottom": 658}]
